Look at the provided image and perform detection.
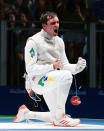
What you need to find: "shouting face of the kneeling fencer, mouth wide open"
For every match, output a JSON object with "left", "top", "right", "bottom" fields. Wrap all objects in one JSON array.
[{"left": 44, "top": 16, "right": 59, "bottom": 36}]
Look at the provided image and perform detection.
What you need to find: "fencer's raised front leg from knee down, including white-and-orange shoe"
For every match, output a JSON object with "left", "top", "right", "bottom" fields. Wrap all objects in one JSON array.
[{"left": 43, "top": 71, "right": 80, "bottom": 127}]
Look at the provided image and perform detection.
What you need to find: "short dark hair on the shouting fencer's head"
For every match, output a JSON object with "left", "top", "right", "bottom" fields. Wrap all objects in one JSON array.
[{"left": 40, "top": 11, "right": 57, "bottom": 24}]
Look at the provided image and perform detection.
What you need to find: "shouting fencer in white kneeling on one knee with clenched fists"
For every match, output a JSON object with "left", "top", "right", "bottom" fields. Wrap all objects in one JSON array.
[{"left": 13, "top": 12, "right": 86, "bottom": 127}]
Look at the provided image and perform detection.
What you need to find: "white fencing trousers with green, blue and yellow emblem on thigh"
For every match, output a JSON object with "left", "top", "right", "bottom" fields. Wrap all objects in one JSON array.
[{"left": 32, "top": 70, "right": 72, "bottom": 119}]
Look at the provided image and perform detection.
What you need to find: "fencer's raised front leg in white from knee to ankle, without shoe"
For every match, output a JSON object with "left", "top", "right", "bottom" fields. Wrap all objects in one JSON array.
[{"left": 43, "top": 71, "right": 72, "bottom": 119}]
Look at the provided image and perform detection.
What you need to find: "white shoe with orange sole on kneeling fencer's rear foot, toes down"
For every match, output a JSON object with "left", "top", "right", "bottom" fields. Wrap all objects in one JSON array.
[{"left": 13, "top": 105, "right": 29, "bottom": 123}]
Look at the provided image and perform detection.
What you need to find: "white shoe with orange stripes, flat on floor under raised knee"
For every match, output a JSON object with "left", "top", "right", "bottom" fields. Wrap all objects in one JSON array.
[{"left": 53, "top": 115, "right": 80, "bottom": 127}]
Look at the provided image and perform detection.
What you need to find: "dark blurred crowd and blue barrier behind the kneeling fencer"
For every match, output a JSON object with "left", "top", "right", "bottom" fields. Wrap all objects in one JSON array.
[{"left": 0, "top": 0, "right": 104, "bottom": 119}]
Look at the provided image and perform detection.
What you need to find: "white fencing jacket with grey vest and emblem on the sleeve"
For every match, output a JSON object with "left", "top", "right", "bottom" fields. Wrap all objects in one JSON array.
[{"left": 25, "top": 29, "right": 76, "bottom": 77}]
